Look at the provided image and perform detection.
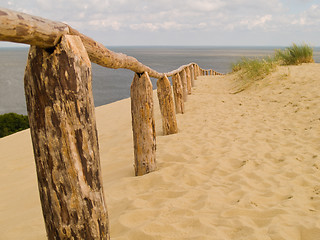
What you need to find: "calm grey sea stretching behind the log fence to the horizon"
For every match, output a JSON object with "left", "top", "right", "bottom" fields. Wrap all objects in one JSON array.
[{"left": 0, "top": 46, "right": 320, "bottom": 114}]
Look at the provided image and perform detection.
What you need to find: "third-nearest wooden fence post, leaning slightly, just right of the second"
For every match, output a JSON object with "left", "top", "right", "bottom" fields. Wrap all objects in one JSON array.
[{"left": 157, "top": 76, "right": 178, "bottom": 135}]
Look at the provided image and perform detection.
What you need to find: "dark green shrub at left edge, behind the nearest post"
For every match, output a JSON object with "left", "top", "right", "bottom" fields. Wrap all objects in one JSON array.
[{"left": 0, "top": 113, "right": 29, "bottom": 138}]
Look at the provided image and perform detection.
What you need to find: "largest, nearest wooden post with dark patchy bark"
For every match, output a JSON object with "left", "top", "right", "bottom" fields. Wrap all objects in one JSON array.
[{"left": 24, "top": 36, "right": 110, "bottom": 239}]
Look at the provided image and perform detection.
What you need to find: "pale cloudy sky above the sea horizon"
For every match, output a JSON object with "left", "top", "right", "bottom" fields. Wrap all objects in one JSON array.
[{"left": 0, "top": 0, "right": 320, "bottom": 46}]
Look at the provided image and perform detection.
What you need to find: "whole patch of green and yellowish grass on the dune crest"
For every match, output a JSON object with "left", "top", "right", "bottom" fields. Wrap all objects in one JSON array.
[{"left": 232, "top": 44, "right": 314, "bottom": 93}]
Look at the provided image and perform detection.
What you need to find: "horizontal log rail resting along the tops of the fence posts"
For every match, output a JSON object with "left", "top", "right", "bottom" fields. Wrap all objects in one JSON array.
[{"left": 0, "top": 8, "right": 222, "bottom": 78}]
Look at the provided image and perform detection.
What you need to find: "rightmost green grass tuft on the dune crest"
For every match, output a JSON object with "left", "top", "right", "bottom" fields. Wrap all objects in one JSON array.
[{"left": 275, "top": 44, "right": 314, "bottom": 65}]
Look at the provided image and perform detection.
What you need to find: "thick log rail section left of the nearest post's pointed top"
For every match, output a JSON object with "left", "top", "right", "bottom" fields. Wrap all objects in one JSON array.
[{"left": 0, "top": 8, "right": 69, "bottom": 48}]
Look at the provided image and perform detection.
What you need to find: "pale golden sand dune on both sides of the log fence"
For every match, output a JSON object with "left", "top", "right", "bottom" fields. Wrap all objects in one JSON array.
[{"left": 0, "top": 64, "right": 320, "bottom": 240}]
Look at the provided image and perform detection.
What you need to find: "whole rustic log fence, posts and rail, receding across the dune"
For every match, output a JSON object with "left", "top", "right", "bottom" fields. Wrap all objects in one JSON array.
[{"left": 0, "top": 8, "right": 224, "bottom": 239}]
